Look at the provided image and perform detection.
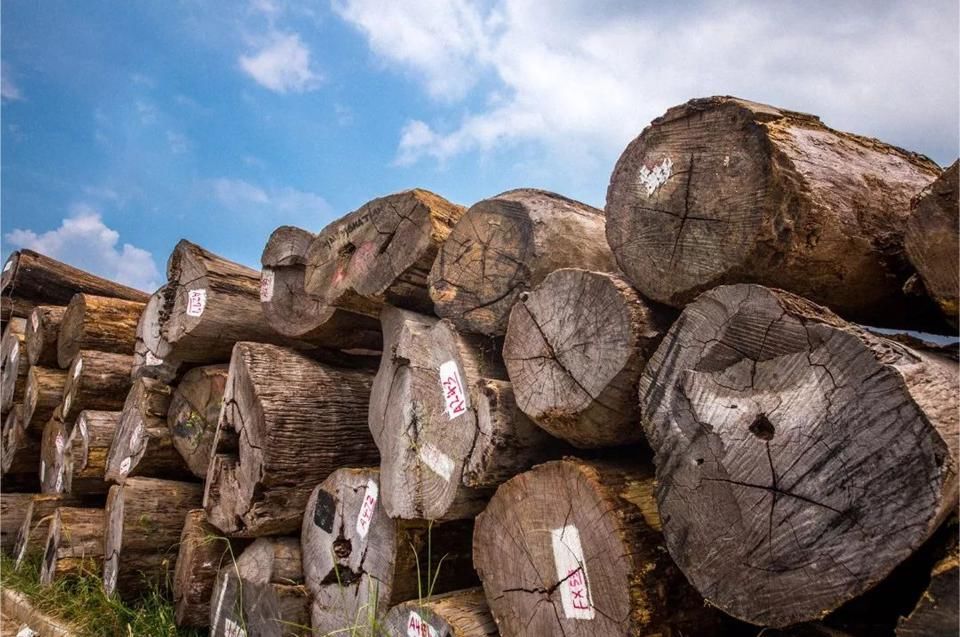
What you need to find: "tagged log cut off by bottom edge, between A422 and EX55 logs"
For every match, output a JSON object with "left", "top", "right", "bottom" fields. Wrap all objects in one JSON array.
[{"left": 382, "top": 588, "right": 500, "bottom": 637}]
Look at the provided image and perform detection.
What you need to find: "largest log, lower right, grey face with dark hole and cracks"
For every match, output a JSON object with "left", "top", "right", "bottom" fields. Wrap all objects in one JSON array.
[{"left": 640, "top": 285, "right": 958, "bottom": 626}]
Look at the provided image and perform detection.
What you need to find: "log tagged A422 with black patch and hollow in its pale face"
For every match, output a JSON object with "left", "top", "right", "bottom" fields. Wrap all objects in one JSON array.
[{"left": 300, "top": 468, "right": 477, "bottom": 635}]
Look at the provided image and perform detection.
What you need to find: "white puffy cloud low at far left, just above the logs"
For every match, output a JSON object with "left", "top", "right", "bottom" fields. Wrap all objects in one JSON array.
[{"left": 4, "top": 204, "right": 160, "bottom": 292}]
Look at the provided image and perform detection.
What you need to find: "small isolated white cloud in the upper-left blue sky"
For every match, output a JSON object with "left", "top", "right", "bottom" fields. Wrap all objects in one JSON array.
[{"left": 240, "top": 33, "right": 320, "bottom": 93}]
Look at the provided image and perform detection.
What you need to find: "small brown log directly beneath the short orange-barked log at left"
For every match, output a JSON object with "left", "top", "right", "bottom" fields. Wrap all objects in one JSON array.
[{"left": 60, "top": 350, "right": 133, "bottom": 428}]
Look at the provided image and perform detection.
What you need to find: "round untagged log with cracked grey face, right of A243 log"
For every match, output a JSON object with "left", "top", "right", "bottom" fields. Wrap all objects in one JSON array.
[{"left": 503, "top": 269, "right": 674, "bottom": 448}]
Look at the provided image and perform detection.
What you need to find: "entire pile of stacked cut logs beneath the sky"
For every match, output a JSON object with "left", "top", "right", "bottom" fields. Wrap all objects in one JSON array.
[{"left": 0, "top": 97, "right": 960, "bottom": 637}]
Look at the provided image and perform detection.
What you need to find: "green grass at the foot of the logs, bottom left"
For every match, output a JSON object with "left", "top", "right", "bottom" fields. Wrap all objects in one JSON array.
[{"left": 0, "top": 555, "right": 206, "bottom": 637}]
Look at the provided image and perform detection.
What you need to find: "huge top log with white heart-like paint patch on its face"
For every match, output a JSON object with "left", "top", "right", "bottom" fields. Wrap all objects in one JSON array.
[{"left": 606, "top": 97, "right": 940, "bottom": 326}]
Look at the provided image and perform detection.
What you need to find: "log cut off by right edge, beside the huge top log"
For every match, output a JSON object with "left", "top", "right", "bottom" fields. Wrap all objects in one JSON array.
[{"left": 904, "top": 162, "right": 960, "bottom": 327}]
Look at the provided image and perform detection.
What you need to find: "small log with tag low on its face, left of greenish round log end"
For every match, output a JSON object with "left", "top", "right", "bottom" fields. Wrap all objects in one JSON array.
[{"left": 105, "top": 377, "right": 194, "bottom": 484}]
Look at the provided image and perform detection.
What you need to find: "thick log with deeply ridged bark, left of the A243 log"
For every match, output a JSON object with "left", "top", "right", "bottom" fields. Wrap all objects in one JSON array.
[{"left": 204, "top": 343, "right": 379, "bottom": 537}]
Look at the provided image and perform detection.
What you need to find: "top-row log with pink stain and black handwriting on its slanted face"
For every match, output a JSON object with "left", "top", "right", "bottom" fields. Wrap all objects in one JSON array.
[{"left": 304, "top": 189, "right": 466, "bottom": 317}]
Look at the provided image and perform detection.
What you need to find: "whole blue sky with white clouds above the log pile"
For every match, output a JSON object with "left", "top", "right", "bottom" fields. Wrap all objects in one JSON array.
[{"left": 0, "top": 0, "right": 960, "bottom": 289}]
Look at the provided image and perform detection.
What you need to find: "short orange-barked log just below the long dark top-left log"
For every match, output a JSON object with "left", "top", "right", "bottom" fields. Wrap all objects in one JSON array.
[{"left": 57, "top": 294, "right": 146, "bottom": 368}]
